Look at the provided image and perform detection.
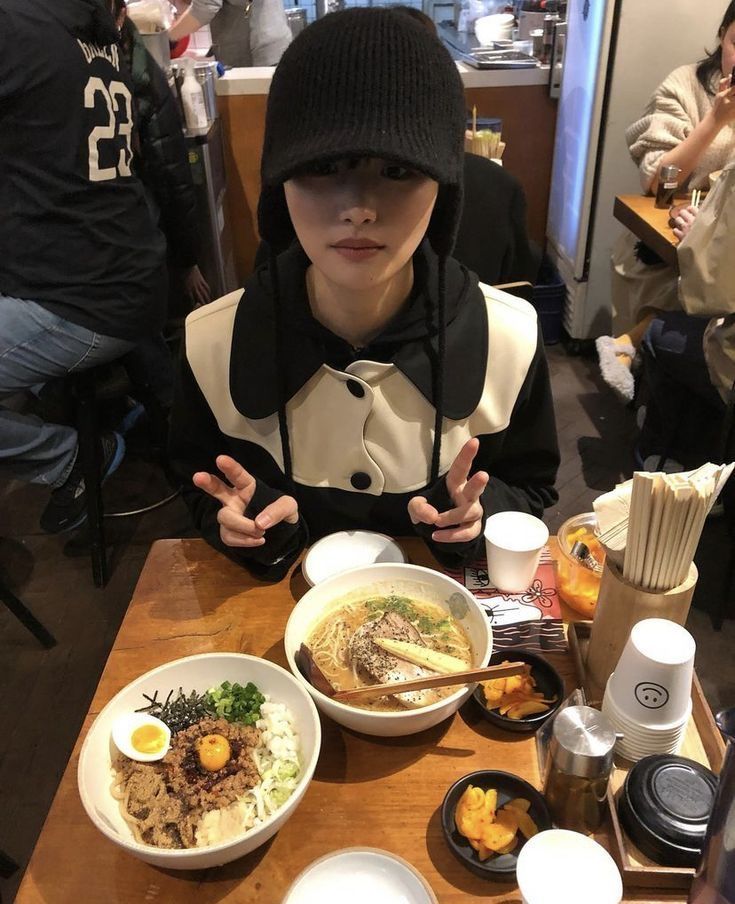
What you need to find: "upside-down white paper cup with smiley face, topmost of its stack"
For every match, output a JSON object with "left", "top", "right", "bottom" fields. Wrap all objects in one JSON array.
[{"left": 607, "top": 618, "right": 696, "bottom": 728}]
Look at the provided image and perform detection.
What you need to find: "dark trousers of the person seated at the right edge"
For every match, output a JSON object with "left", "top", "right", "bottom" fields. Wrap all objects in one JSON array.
[{"left": 639, "top": 311, "right": 725, "bottom": 468}]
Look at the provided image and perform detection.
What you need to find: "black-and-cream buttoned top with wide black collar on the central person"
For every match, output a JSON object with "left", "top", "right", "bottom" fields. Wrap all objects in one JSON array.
[{"left": 171, "top": 243, "right": 559, "bottom": 580}]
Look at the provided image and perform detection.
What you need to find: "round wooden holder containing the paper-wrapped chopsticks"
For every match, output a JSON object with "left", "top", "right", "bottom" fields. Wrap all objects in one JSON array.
[{"left": 586, "top": 558, "right": 698, "bottom": 702}]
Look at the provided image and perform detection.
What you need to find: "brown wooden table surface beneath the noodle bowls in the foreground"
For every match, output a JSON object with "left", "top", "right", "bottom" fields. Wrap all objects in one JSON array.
[{"left": 16, "top": 540, "right": 696, "bottom": 904}]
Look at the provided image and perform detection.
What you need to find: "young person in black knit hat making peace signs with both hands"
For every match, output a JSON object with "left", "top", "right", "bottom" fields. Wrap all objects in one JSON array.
[{"left": 171, "top": 8, "right": 559, "bottom": 579}]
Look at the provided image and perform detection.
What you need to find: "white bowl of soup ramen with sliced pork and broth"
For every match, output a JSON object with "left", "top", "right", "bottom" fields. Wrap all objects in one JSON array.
[{"left": 284, "top": 563, "right": 492, "bottom": 737}]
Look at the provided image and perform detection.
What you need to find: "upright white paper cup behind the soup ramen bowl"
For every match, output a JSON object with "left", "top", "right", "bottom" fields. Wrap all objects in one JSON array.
[{"left": 485, "top": 512, "right": 549, "bottom": 593}]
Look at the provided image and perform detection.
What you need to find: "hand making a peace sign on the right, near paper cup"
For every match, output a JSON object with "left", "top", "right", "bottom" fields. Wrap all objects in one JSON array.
[{"left": 408, "top": 438, "right": 490, "bottom": 543}]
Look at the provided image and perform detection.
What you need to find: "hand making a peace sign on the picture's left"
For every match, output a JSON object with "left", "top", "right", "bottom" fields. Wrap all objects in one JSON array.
[{"left": 192, "top": 455, "right": 299, "bottom": 547}]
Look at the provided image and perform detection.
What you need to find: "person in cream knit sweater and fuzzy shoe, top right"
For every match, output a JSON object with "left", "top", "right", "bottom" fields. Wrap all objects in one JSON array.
[{"left": 596, "top": 0, "right": 735, "bottom": 401}]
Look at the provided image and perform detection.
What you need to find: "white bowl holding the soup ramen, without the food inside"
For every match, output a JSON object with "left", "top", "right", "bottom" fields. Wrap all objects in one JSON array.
[{"left": 284, "top": 563, "right": 492, "bottom": 737}]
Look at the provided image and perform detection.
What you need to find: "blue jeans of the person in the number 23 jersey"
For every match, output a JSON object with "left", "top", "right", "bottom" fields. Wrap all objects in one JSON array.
[{"left": 0, "top": 293, "right": 135, "bottom": 487}]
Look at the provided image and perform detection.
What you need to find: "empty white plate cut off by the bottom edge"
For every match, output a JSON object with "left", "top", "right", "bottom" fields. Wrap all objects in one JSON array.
[{"left": 283, "top": 848, "right": 437, "bottom": 904}]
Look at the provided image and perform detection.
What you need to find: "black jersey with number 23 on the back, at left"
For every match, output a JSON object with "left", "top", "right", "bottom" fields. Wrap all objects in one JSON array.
[{"left": 0, "top": 0, "right": 165, "bottom": 340}]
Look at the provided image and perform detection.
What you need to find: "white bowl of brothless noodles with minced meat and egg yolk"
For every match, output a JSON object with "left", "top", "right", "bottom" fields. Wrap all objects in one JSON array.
[{"left": 77, "top": 653, "right": 321, "bottom": 869}]
